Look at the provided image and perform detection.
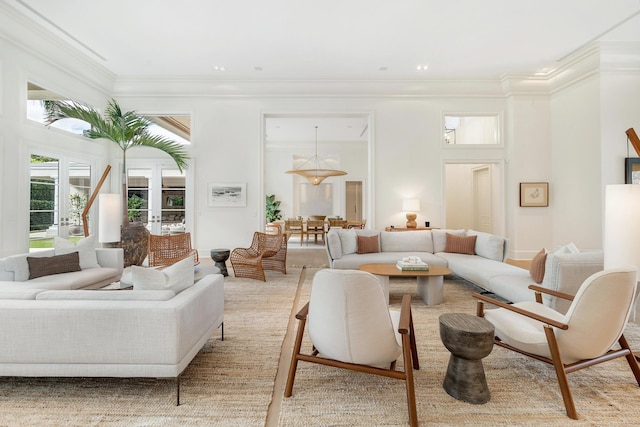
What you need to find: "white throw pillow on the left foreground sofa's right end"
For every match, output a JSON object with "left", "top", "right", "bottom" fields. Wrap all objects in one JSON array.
[{"left": 131, "top": 256, "right": 194, "bottom": 294}]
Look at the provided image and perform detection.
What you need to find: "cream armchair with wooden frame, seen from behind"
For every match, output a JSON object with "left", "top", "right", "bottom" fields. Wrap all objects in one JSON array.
[{"left": 284, "top": 269, "right": 420, "bottom": 426}]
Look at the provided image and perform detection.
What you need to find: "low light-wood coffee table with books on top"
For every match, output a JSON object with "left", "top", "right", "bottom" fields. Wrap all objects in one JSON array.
[{"left": 358, "top": 264, "right": 451, "bottom": 305}]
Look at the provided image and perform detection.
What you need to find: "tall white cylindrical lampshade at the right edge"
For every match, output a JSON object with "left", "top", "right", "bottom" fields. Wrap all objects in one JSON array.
[{"left": 603, "top": 184, "right": 640, "bottom": 269}]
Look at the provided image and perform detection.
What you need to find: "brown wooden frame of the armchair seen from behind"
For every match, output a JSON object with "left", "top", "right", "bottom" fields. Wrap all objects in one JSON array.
[{"left": 284, "top": 295, "right": 420, "bottom": 426}]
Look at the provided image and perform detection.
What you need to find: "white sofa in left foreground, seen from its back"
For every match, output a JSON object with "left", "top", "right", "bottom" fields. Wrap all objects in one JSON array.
[{"left": 0, "top": 274, "right": 224, "bottom": 403}]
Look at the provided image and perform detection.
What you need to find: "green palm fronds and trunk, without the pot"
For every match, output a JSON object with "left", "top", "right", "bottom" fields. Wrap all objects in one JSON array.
[{"left": 45, "top": 99, "right": 189, "bottom": 226}]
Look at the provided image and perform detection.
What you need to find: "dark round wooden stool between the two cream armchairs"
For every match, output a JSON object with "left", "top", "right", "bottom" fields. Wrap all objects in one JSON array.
[{"left": 439, "top": 313, "right": 495, "bottom": 403}]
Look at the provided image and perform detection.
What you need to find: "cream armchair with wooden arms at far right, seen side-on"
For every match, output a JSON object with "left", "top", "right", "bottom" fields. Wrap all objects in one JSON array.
[{"left": 473, "top": 266, "right": 640, "bottom": 419}]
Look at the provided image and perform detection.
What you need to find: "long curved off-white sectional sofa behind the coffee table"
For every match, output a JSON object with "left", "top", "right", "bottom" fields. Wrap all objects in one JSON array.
[{"left": 326, "top": 228, "right": 603, "bottom": 310}]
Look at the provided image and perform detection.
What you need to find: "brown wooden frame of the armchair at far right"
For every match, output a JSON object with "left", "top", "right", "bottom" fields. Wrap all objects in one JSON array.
[{"left": 473, "top": 285, "right": 640, "bottom": 420}]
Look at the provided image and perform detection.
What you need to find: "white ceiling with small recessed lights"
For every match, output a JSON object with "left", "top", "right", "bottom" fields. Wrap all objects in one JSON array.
[{"left": 8, "top": 0, "right": 640, "bottom": 80}]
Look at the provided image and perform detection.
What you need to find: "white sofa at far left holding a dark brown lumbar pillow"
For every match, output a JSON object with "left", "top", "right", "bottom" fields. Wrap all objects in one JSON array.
[{"left": 0, "top": 247, "right": 124, "bottom": 290}]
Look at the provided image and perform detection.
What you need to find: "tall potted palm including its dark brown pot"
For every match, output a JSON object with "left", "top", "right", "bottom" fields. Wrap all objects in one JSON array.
[{"left": 45, "top": 99, "right": 189, "bottom": 267}]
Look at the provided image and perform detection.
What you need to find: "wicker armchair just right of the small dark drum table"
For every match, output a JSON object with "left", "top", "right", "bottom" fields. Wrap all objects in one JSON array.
[{"left": 229, "top": 231, "right": 287, "bottom": 282}]
